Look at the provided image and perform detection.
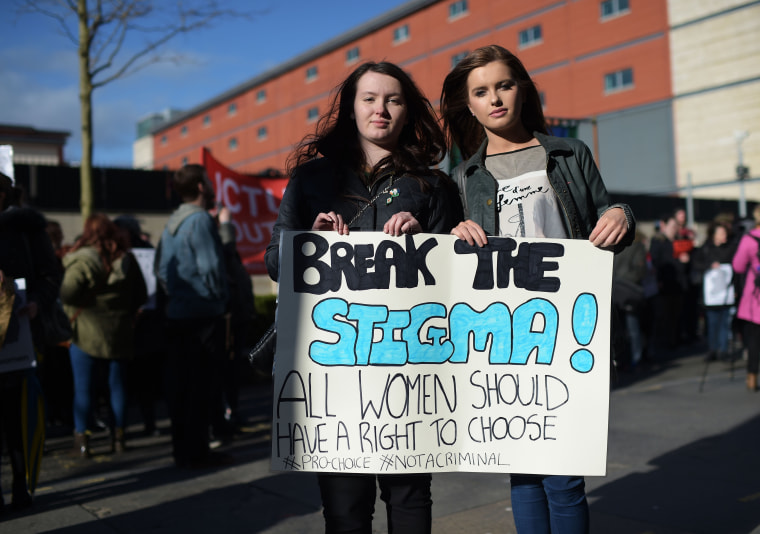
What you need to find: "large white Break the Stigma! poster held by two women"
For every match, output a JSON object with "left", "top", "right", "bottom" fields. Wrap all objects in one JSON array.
[{"left": 271, "top": 232, "right": 612, "bottom": 475}]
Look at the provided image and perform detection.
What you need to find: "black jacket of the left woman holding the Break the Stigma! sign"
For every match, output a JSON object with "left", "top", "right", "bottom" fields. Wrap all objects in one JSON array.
[{"left": 265, "top": 158, "right": 462, "bottom": 281}]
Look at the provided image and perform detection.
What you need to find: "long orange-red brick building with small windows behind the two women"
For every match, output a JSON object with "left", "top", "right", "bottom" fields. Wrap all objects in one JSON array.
[{"left": 153, "top": 0, "right": 674, "bottom": 189}]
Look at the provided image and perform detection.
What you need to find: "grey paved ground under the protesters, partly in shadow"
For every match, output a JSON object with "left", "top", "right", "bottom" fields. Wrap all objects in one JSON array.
[{"left": 0, "top": 347, "right": 760, "bottom": 534}]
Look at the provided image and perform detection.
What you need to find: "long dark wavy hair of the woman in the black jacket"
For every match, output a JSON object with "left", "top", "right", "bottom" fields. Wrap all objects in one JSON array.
[{"left": 287, "top": 61, "right": 446, "bottom": 183}]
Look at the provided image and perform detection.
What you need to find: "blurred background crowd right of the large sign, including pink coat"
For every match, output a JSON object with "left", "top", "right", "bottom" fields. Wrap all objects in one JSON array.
[{"left": 612, "top": 208, "right": 760, "bottom": 391}]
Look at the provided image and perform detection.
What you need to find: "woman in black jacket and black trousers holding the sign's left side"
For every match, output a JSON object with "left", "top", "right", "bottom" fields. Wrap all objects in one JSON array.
[{"left": 266, "top": 62, "right": 462, "bottom": 534}]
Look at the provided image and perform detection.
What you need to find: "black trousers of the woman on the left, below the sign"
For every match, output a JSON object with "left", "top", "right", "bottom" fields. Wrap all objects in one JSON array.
[{"left": 317, "top": 474, "right": 433, "bottom": 534}]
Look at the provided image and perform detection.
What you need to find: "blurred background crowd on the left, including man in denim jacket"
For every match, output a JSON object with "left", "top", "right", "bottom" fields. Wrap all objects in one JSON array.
[{"left": 0, "top": 165, "right": 256, "bottom": 513}]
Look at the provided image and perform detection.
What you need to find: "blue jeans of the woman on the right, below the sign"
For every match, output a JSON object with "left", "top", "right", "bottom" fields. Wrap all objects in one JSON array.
[{"left": 511, "top": 475, "right": 589, "bottom": 534}]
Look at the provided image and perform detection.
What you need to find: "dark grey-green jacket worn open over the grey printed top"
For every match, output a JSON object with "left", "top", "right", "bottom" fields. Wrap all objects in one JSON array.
[{"left": 453, "top": 132, "right": 636, "bottom": 251}]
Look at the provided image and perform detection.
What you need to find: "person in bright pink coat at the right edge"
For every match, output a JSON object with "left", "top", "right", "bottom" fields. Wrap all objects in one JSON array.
[{"left": 732, "top": 206, "right": 760, "bottom": 391}]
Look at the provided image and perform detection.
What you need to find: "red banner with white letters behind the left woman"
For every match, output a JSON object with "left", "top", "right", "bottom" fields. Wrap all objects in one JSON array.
[{"left": 201, "top": 148, "right": 288, "bottom": 274}]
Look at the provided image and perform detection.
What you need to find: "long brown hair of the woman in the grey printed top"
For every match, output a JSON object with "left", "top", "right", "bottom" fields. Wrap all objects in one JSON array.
[{"left": 441, "top": 45, "right": 548, "bottom": 159}]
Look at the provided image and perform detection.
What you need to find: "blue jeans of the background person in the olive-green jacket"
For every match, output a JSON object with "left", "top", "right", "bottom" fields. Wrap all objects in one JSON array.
[{"left": 69, "top": 343, "right": 127, "bottom": 433}]
